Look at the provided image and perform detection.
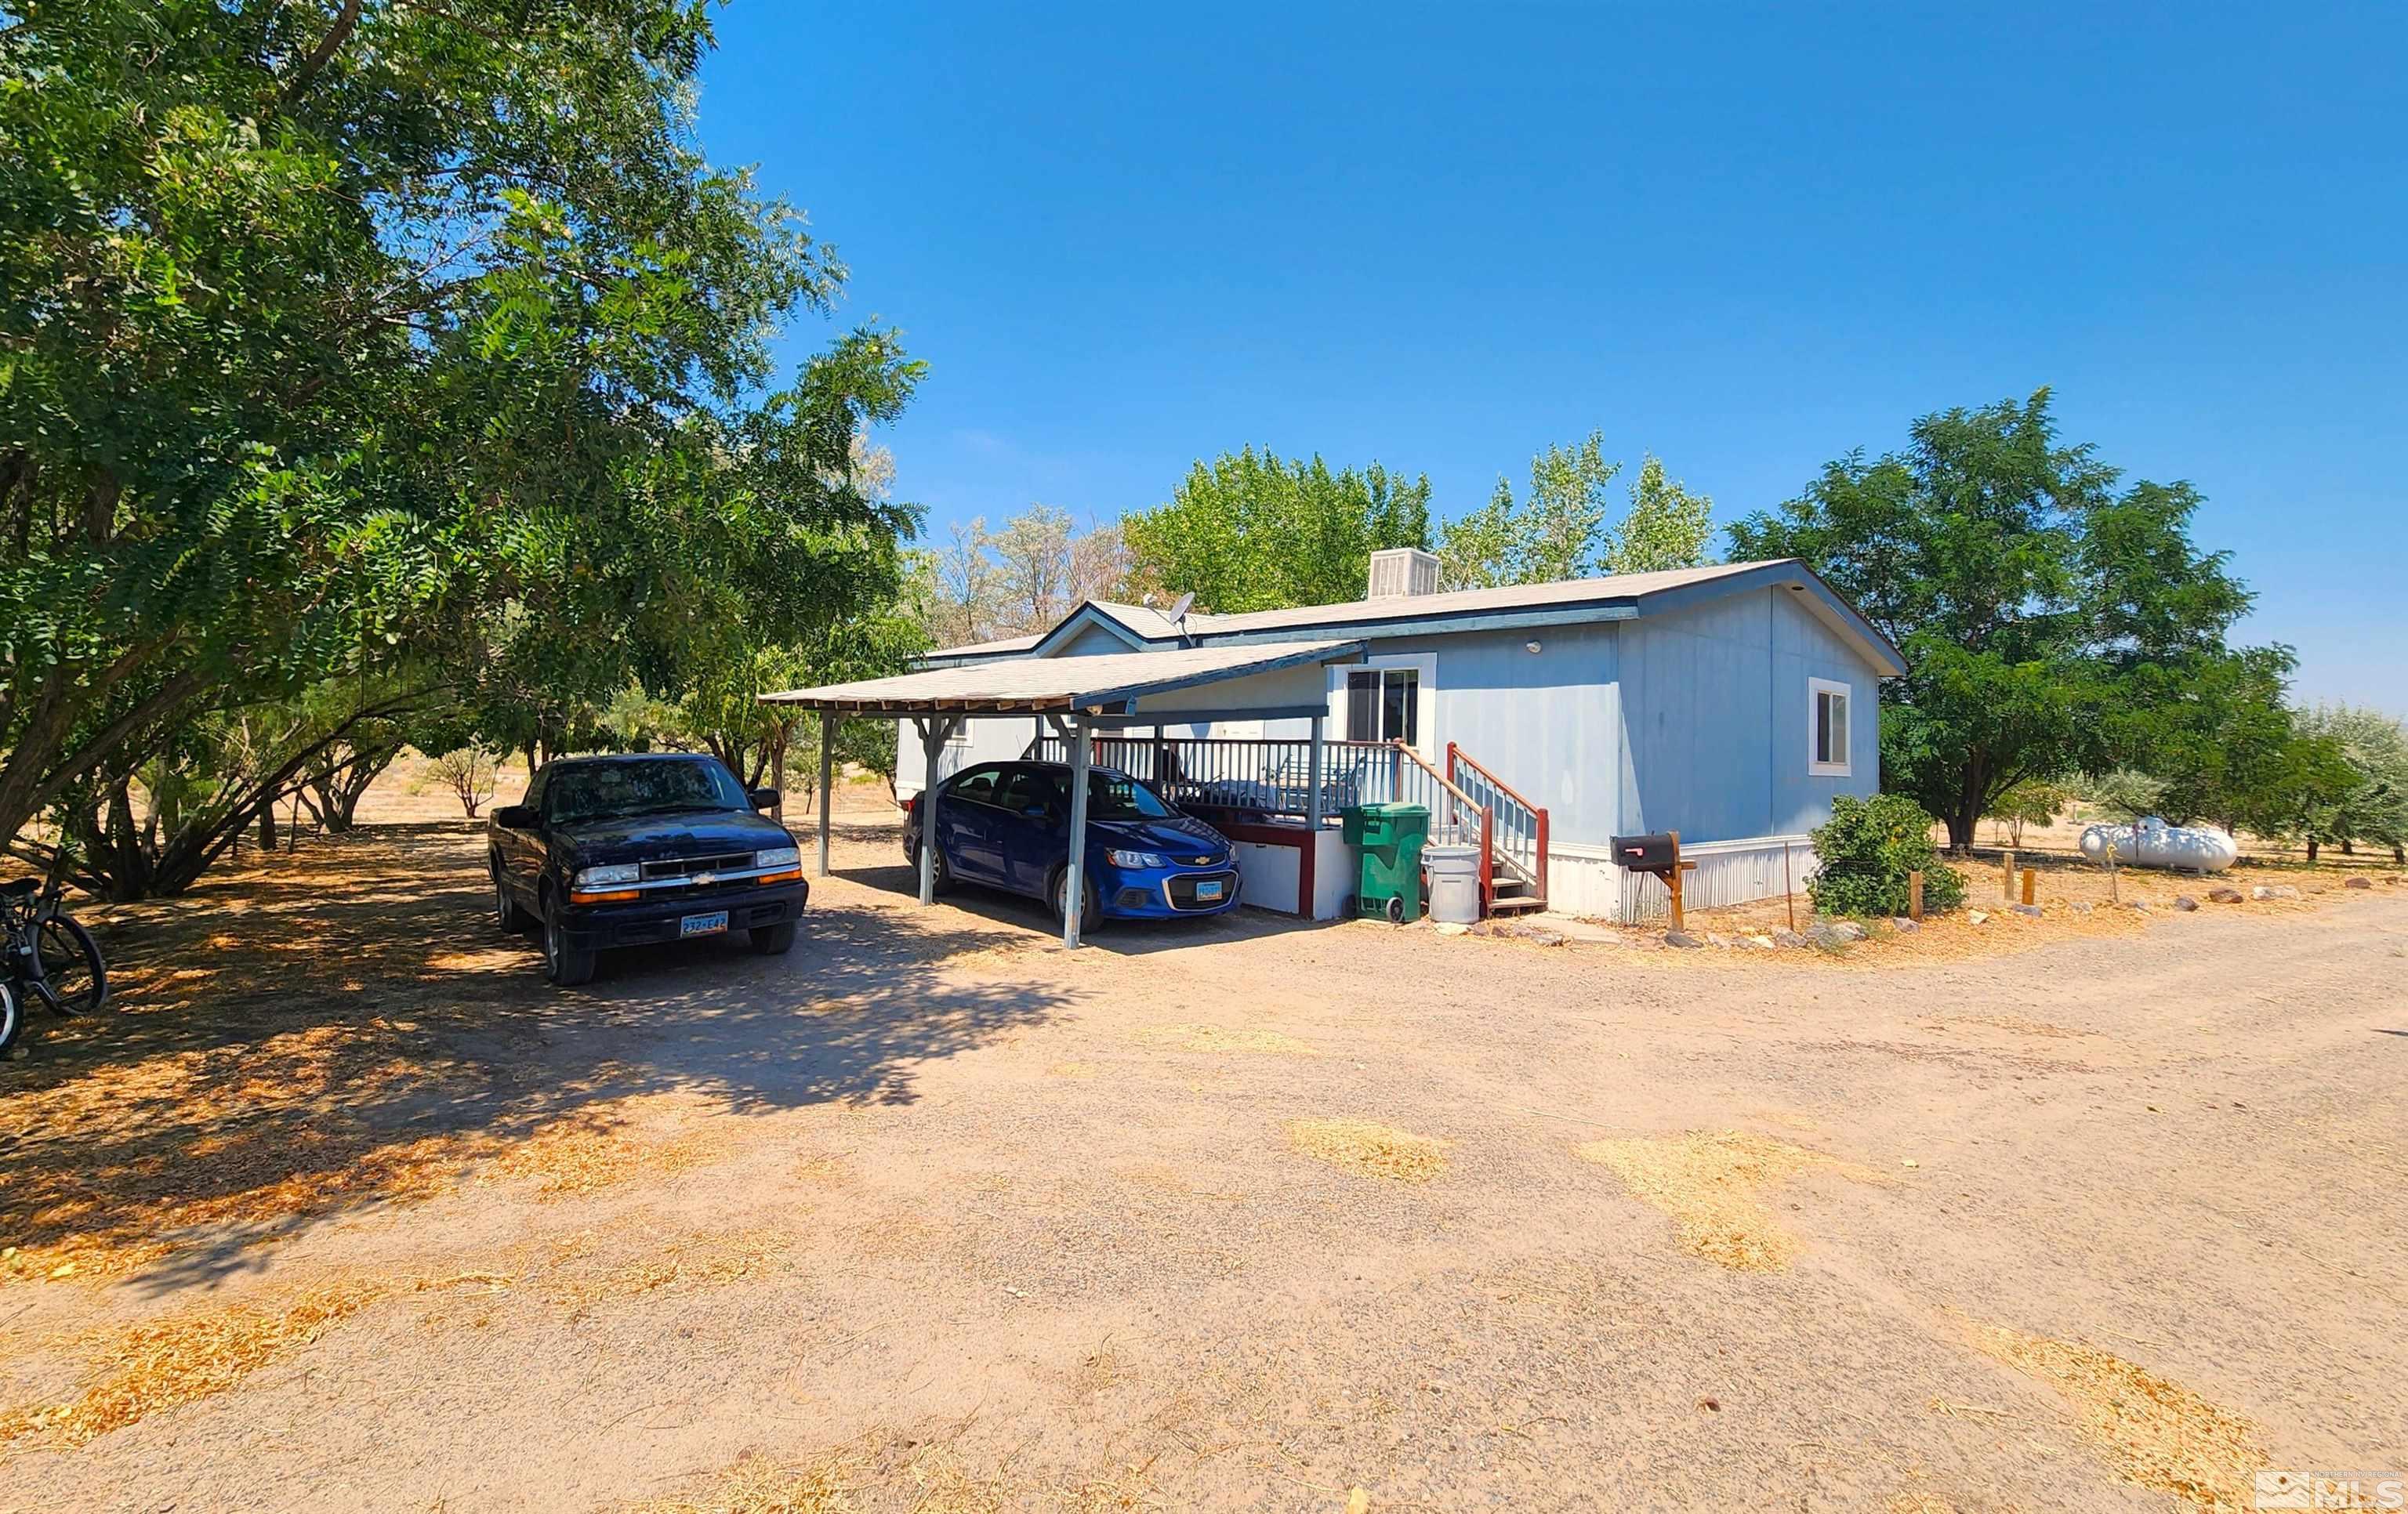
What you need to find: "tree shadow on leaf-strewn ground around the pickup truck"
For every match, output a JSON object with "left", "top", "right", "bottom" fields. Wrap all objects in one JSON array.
[{"left": 0, "top": 826, "right": 1062, "bottom": 1288}]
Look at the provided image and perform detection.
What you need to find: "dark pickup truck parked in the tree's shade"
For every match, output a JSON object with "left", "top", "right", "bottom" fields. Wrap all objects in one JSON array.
[{"left": 487, "top": 753, "right": 811, "bottom": 984}]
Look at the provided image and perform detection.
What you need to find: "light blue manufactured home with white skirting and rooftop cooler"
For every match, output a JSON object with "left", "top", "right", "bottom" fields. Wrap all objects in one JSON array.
[{"left": 872, "top": 549, "right": 1905, "bottom": 919}]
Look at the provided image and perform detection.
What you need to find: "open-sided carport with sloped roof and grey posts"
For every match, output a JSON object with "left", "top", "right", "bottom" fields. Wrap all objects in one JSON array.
[{"left": 761, "top": 640, "right": 1363, "bottom": 946}]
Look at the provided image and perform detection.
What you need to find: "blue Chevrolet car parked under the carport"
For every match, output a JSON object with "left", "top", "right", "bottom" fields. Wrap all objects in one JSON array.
[{"left": 903, "top": 763, "right": 1238, "bottom": 919}]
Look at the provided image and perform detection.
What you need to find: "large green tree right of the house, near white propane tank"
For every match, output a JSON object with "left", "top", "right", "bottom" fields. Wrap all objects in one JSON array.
[{"left": 1732, "top": 390, "right": 2249, "bottom": 847}]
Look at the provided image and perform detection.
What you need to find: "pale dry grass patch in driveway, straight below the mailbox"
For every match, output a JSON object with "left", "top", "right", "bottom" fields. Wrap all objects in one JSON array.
[{"left": 1572, "top": 1132, "right": 1888, "bottom": 1271}]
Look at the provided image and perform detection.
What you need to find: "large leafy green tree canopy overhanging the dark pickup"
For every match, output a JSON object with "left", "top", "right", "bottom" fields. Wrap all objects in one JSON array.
[{"left": 0, "top": 0, "right": 917, "bottom": 852}]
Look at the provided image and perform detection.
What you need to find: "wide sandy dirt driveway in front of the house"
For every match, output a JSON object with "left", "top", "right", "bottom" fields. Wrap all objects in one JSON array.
[{"left": 0, "top": 799, "right": 2408, "bottom": 1512}]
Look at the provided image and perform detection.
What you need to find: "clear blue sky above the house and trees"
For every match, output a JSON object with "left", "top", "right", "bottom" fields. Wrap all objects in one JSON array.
[{"left": 701, "top": 0, "right": 2408, "bottom": 712}]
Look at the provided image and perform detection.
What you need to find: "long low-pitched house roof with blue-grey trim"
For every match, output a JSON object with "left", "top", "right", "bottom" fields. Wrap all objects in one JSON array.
[{"left": 927, "top": 559, "right": 1907, "bottom": 674}]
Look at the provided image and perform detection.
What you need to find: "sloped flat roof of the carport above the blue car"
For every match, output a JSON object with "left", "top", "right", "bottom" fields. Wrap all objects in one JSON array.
[{"left": 761, "top": 640, "right": 1363, "bottom": 717}]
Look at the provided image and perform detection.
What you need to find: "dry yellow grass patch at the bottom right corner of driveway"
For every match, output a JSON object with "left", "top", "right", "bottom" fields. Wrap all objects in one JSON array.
[{"left": 1972, "top": 1326, "right": 2271, "bottom": 1514}]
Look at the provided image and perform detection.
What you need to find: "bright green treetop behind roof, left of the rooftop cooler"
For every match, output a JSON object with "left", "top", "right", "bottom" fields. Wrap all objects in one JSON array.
[{"left": 1119, "top": 447, "right": 1431, "bottom": 614}]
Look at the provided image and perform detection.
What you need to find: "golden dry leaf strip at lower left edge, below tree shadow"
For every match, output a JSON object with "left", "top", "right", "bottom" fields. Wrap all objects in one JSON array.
[{"left": 0, "top": 1283, "right": 390, "bottom": 1447}]
